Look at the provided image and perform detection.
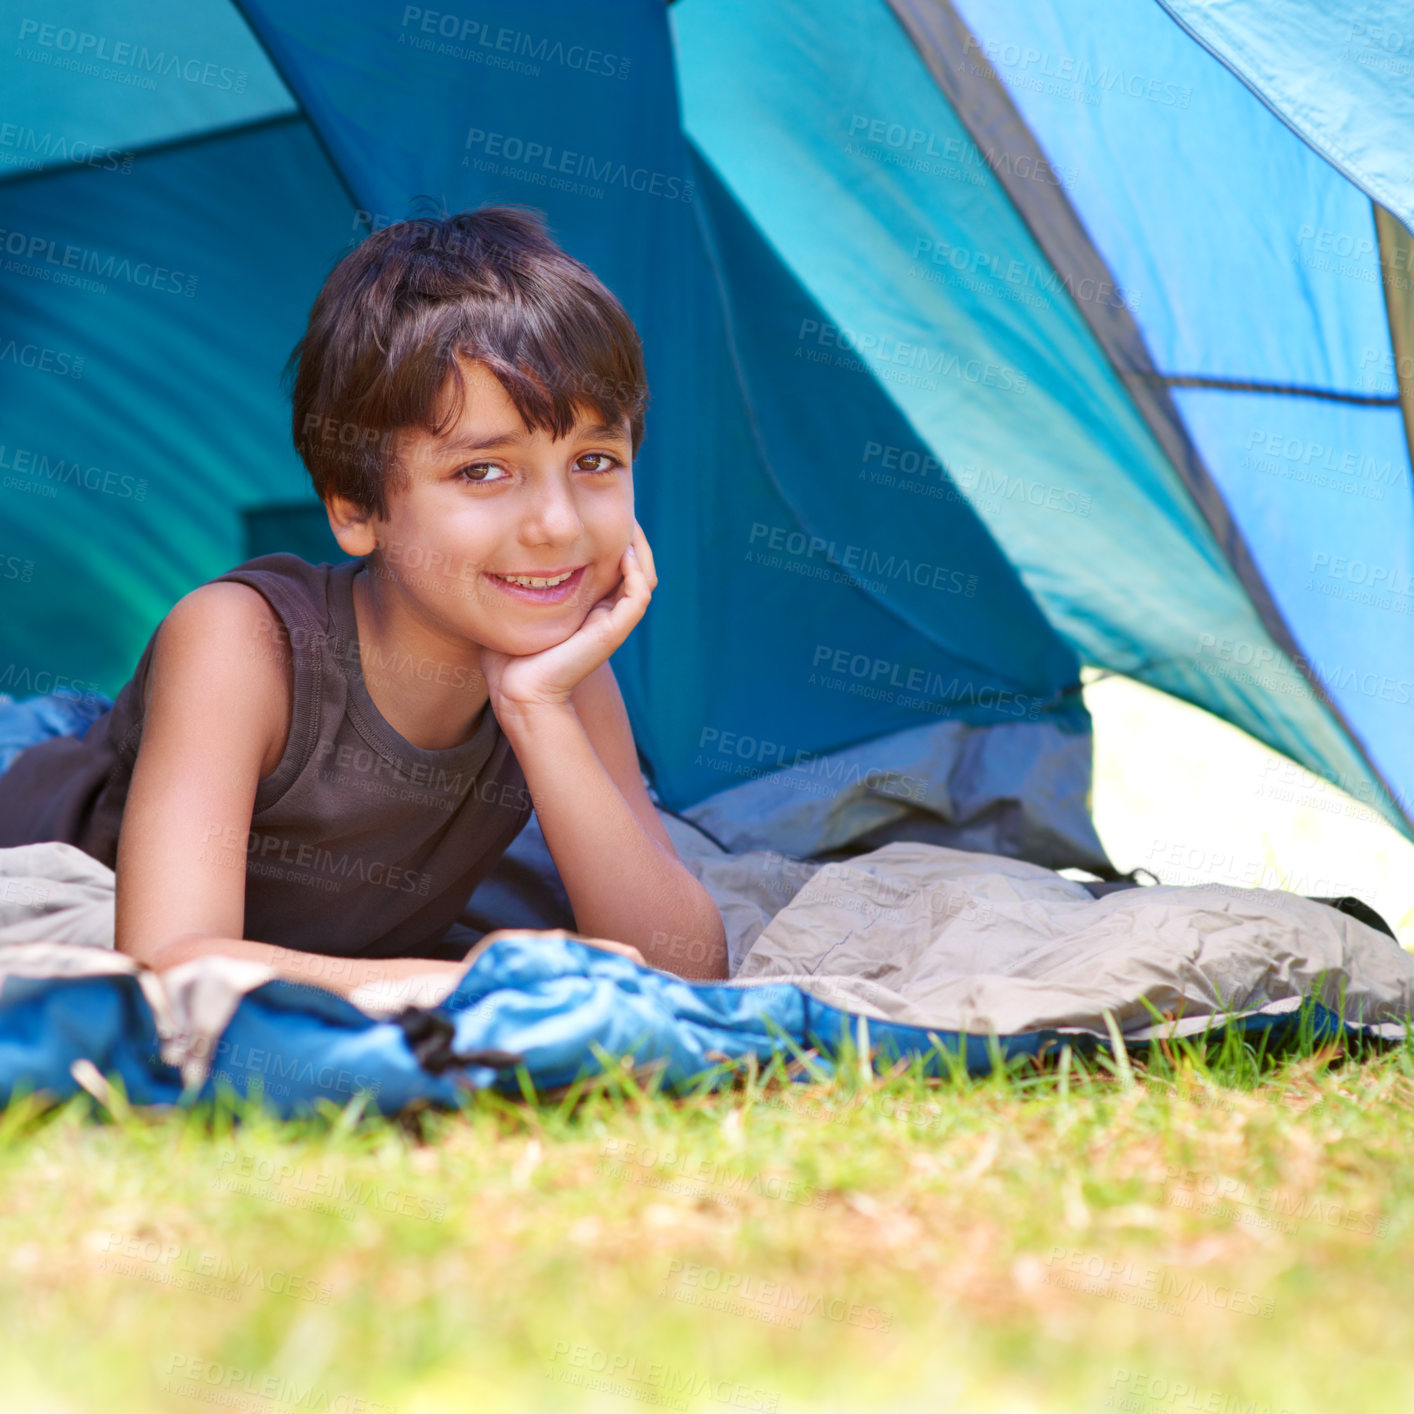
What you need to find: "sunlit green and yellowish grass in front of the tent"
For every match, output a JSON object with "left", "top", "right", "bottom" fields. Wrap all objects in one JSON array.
[{"left": 0, "top": 1034, "right": 1414, "bottom": 1414}]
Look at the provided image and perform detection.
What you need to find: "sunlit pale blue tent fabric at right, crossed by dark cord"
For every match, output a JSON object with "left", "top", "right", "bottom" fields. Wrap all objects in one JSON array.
[{"left": 933, "top": 0, "right": 1414, "bottom": 816}]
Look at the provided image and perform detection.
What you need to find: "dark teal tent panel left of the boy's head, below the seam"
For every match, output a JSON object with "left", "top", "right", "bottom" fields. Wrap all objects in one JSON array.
[{"left": 0, "top": 119, "right": 354, "bottom": 697}]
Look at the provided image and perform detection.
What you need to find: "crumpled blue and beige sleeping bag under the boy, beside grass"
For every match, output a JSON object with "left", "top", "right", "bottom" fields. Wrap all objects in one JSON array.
[{"left": 0, "top": 836, "right": 1414, "bottom": 1114}]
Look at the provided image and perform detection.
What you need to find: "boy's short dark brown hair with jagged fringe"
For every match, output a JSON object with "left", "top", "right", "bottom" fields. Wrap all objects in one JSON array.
[{"left": 284, "top": 205, "right": 648, "bottom": 516}]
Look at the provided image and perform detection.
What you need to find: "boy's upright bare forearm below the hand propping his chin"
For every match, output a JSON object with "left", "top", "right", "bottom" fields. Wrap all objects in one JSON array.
[{"left": 502, "top": 703, "right": 727, "bottom": 980}]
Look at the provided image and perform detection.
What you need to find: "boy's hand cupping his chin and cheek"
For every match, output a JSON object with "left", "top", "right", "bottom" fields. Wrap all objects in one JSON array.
[{"left": 481, "top": 520, "right": 658, "bottom": 725}]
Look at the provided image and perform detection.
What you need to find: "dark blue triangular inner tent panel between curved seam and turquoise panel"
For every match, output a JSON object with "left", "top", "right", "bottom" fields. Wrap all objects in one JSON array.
[{"left": 700, "top": 143, "right": 1080, "bottom": 701}]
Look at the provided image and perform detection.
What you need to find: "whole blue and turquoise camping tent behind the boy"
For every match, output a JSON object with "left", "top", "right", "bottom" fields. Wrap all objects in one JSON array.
[{"left": 0, "top": 0, "right": 1414, "bottom": 865}]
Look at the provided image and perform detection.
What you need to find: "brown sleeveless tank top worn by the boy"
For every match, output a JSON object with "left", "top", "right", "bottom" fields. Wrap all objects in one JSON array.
[{"left": 0, "top": 554, "right": 532, "bottom": 957}]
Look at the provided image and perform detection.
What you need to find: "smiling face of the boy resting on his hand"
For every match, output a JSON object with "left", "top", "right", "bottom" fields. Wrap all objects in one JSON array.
[{"left": 356, "top": 358, "right": 633, "bottom": 656}]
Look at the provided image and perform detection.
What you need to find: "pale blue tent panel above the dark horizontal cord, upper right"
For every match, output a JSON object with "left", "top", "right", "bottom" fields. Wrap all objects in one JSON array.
[{"left": 957, "top": 0, "right": 1396, "bottom": 396}]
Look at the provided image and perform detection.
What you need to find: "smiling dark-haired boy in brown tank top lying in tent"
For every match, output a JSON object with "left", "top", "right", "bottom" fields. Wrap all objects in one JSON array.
[{"left": 0, "top": 206, "right": 727, "bottom": 993}]
